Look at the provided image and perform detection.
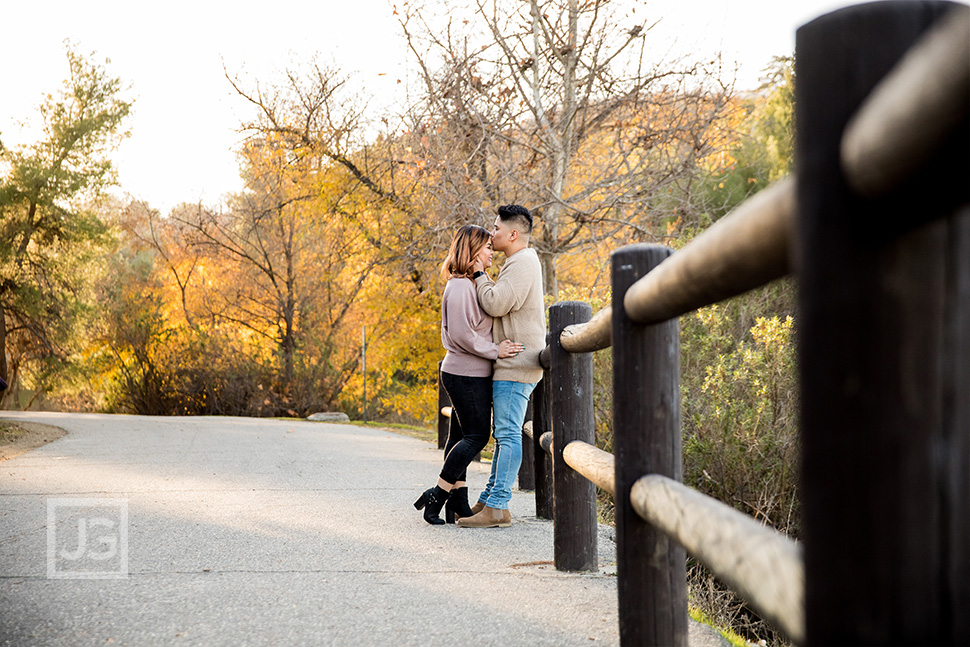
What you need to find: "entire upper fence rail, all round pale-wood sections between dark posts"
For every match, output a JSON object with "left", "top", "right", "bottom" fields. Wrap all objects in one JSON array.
[{"left": 560, "top": 7, "right": 970, "bottom": 353}]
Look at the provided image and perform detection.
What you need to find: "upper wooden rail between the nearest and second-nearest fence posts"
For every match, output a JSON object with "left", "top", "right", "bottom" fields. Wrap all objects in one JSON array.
[{"left": 623, "top": 178, "right": 796, "bottom": 324}]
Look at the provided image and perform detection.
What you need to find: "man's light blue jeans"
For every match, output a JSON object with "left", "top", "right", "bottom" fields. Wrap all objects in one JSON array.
[{"left": 478, "top": 380, "right": 536, "bottom": 510}]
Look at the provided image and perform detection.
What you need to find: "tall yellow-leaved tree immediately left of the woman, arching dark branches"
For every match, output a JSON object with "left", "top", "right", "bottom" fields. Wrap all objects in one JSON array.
[{"left": 219, "top": 62, "right": 450, "bottom": 416}]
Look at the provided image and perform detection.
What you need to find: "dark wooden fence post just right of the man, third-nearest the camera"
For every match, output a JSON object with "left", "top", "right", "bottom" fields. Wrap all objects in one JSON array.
[{"left": 549, "top": 301, "right": 599, "bottom": 571}]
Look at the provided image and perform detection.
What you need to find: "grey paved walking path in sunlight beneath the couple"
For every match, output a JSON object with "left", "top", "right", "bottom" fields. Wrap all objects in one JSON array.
[{"left": 0, "top": 411, "right": 728, "bottom": 647}]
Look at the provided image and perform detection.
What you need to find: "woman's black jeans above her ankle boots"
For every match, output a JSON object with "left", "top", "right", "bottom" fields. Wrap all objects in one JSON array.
[{"left": 440, "top": 371, "right": 492, "bottom": 485}]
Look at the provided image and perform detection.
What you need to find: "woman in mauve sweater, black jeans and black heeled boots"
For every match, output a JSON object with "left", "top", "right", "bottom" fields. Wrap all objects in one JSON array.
[{"left": 414, "top": 225, "right": 523, "bottom": 525}]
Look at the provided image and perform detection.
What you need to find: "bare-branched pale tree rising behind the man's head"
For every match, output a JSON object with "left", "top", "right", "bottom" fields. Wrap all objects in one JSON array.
[{"left": 400, "top": 0, "right": 730, "bottom": 297}]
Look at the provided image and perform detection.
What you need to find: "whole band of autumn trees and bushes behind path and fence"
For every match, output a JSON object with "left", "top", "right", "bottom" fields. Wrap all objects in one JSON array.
[{"left": 0, "top": 24, "right": 799, "bottom": 644}]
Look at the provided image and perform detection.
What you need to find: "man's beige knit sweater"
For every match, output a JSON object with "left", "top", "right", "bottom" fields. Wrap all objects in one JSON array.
[{"left": 475, "top": 247, "right": 546, "bottom": 384}]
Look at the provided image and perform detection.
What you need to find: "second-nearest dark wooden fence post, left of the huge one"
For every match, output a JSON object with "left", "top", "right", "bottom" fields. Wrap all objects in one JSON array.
[{"left": 611, "top": 245, "right": 687, "bottom": 647}]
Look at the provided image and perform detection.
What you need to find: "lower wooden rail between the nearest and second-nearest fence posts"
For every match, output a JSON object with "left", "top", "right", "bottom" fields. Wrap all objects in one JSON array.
[{"left": 630, "top": 474, "right": 805, "bottom": 644}]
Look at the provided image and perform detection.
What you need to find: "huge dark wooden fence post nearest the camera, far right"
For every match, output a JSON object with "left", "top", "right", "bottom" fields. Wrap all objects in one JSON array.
[{"left": 796, "top": 2, "right": 970, "bottom": 645}]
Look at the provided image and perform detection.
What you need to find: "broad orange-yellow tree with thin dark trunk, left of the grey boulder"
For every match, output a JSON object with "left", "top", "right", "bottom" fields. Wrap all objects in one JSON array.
[{"left": 114, "top": 133, "right": 396, "bottom": 411}]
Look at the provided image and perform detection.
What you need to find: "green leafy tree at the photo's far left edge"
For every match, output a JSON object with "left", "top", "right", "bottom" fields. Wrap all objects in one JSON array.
[{"left": 0, "top": 45, "right": 131, "bottom": 408}]
